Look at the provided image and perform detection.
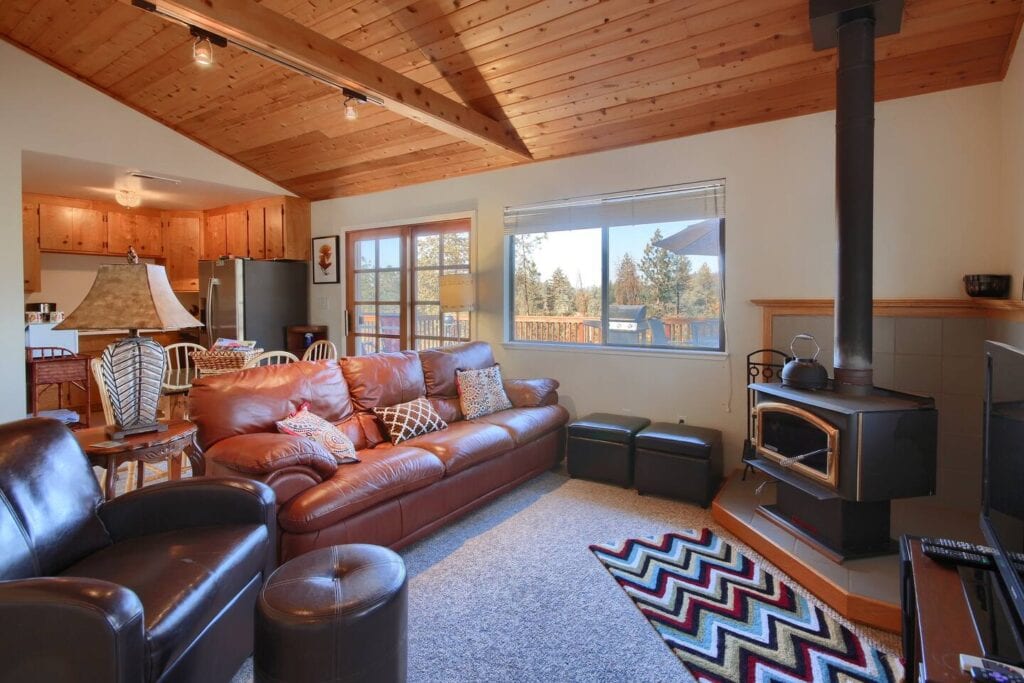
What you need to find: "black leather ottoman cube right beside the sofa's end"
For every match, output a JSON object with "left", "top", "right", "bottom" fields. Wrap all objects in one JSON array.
[{"left": 566, "top": 413, "right": 650, "bottom": 488}]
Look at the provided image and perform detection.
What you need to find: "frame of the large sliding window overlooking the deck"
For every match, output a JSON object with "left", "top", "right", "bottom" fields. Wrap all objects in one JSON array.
[{"left": 504, "top": 216, "right": 728, "bottom": 355}]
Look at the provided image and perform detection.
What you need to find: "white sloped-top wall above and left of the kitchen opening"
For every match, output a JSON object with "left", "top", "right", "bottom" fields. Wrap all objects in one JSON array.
[{"left": 0, "top": 42, "right": 287, "bottom": 421}]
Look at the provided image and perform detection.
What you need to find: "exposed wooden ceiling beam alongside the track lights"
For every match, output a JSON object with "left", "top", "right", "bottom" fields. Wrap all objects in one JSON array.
[{"left": 121, "top": 0, "right": 532, "bottom": 161}]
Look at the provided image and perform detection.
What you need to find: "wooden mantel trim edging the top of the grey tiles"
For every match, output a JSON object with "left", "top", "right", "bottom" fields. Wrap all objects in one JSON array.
[{"left": 751, "top": 298, "right": 1024, "bottom": 348}]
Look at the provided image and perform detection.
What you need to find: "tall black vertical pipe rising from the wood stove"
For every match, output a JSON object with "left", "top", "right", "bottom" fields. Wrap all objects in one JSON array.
[{"left": 834, "top": 7, "right": 876, "bottom": 392}]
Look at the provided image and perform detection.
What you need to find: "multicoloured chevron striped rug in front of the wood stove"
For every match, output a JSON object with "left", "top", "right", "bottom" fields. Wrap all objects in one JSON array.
[{"left": 590, "top": 528, "right": 903, "bottom": 683}]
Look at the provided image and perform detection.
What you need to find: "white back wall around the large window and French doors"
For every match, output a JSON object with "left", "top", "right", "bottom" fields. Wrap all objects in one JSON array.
[{"left": 311, "top": 84, "right": 999, "bottom": 471}]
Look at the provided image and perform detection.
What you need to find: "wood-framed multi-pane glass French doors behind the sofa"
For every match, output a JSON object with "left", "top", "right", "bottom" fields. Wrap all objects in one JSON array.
[{"left": 345, "top": 220, "right": 469, "bottom": 355}]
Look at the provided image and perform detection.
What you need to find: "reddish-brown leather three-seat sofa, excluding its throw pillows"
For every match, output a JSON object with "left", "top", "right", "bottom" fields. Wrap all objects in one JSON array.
[{"left": 189, "top": 342, "right": 568, "bottom": 561}]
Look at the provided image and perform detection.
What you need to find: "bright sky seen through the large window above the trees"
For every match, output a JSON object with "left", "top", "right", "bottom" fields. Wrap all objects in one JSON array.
[{"left": 534, "top": 220, "right": 718, "bottom": 287}]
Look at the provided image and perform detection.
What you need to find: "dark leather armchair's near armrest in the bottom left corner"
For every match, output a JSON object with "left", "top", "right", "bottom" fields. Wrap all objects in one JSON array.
[{"left": 0, "top": 577, "right": 145, "bottom": 683}]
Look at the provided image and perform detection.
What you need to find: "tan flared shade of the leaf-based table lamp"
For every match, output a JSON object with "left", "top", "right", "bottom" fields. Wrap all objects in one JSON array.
[{"left": 55, "top": 263, "right": 203, "bottom": 335}]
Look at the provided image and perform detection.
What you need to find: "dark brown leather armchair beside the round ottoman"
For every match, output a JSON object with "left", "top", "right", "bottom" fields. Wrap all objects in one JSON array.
[{"left": 0, "top": 418, "right": 276, "bottom": 683}]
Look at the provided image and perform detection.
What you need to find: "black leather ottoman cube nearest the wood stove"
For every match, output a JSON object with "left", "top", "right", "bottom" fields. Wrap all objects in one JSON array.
[{"left": 634, "top": 422, "right": 722, "bottom": 508}]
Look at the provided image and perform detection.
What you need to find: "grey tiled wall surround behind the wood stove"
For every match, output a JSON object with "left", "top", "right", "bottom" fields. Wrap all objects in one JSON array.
[{"left": 772, "top": 315, "right": 1024, "bottom": 510}]
